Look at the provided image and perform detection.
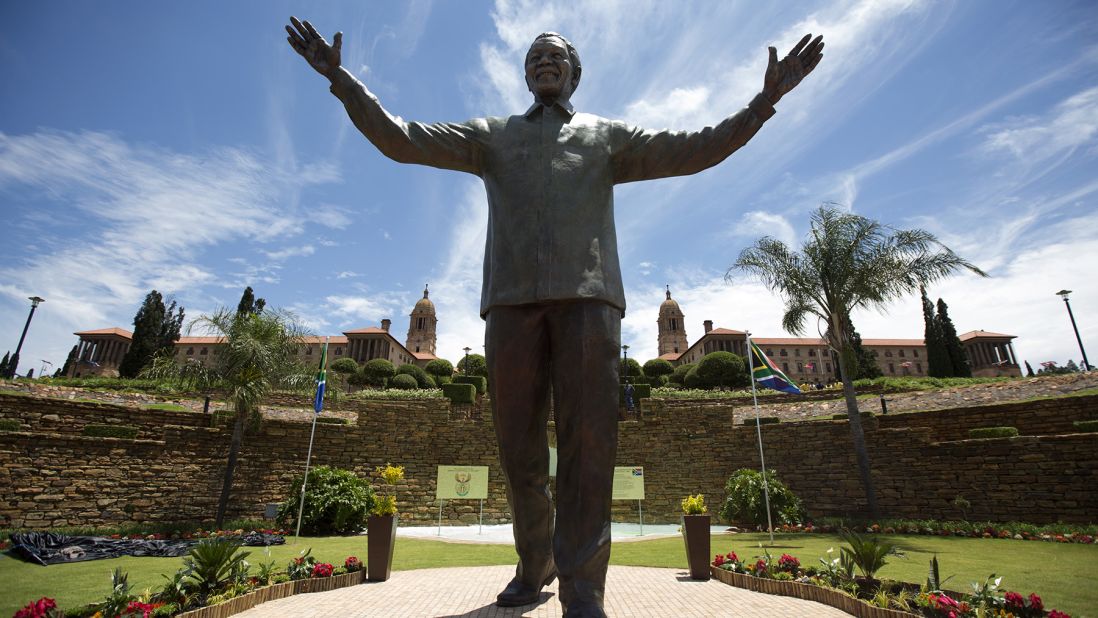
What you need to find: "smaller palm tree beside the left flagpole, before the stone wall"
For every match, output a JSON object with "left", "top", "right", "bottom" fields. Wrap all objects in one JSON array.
[{"left": 143, "top": 307, "right": 313, "bottom": 527}]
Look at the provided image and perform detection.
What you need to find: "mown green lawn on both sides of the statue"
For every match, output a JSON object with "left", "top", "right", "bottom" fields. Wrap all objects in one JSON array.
[{"left": 0, "top": 535, "right": 1098, "bottom": 618}]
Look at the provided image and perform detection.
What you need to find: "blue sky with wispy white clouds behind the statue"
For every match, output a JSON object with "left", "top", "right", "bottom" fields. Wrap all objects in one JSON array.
[{"left": 0, "top": 0, "right": 1098, "bottom": 372}]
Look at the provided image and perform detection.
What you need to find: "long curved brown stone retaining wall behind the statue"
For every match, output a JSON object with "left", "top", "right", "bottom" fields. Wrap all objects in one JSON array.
[{"left": 0, "top": 394, "right": 1098, "bottom": 527}]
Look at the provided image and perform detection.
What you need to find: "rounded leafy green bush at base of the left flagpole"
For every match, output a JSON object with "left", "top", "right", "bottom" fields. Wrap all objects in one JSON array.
[{"left": 278, "top": 465, "right": 377, "bottom": 536}]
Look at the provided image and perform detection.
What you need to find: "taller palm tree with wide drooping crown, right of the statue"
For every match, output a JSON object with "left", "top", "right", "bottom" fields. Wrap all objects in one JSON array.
[{"left": 726, "top": 205, "right": 987, "bottom": 517}]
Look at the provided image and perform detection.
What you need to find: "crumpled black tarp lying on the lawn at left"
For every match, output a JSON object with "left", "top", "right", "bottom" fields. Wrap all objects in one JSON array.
[{"left": 11, "top": 532, "right": 285, "bottom": 566}]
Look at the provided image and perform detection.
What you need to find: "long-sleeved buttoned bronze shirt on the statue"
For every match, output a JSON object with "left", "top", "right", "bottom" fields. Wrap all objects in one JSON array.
[{"left": 332, "top": 70, "right": 774, "bottom": 315}]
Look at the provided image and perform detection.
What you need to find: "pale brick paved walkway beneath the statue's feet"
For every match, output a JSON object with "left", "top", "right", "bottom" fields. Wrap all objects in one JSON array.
[{"left": 236, "top": 565, "right": 849, "bottom": 618}]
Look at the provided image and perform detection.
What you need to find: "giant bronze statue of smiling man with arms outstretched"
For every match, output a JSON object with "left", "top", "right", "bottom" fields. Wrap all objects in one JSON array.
[{"left": 287, "top": 18, "right": 824, "bottom": 618}]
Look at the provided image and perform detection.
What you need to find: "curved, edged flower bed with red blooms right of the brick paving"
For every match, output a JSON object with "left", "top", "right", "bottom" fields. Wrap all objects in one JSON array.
[{"left": 709, "top": 550, "right": 1071, "bottom": 618}]
